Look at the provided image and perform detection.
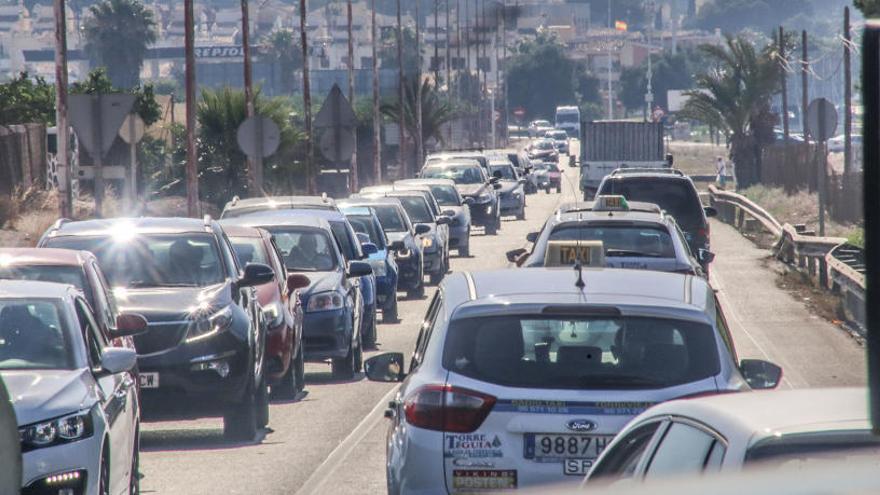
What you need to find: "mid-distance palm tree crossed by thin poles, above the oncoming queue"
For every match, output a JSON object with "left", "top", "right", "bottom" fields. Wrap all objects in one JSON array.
[{"left": 381, "top": 79, "right": 457, "bottom": 150}]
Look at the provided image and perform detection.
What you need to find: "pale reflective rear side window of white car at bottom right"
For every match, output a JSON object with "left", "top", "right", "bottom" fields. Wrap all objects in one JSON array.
[{"left": 645, "top": 423, "right": 715, "bottom": 478}]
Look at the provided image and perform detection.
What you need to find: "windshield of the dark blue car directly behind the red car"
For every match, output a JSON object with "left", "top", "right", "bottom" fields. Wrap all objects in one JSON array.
[{"left": 263, "top": 227, "right": 337, "bottom": 272}]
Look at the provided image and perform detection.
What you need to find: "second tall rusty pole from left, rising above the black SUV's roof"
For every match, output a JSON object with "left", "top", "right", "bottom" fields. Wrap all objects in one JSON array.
[{"left": 183, "top": 0, "right": 200, "bottom": 217}]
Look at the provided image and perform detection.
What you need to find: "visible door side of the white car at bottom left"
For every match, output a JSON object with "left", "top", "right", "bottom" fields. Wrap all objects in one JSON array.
[{"left": 75, "top": 298, "right": 137, "bottom": 492}]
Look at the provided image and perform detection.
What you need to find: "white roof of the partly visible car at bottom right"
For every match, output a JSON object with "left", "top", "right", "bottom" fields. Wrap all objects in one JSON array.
[{"left": 642, "top": 388, "right": 870, "bottom": 443}]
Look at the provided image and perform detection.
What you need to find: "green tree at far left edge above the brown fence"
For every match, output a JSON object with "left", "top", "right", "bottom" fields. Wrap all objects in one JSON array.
[{"left": 0, "top": 72, "right": 55, "bottom": 125}]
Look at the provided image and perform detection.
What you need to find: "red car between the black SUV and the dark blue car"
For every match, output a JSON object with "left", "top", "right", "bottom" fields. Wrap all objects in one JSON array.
[{"left": 223, "top": 225, "right": 311, "bottom": 399}]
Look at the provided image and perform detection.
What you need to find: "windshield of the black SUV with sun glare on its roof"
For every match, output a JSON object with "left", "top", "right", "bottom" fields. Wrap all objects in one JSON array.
[{"left": 47, "top": 233, "right": 226, "bottom": 289}]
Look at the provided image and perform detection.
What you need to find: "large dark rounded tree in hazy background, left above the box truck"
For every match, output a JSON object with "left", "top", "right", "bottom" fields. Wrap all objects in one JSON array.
[{"left": 507, "top": 33, "right": 576, "bottom": 119}]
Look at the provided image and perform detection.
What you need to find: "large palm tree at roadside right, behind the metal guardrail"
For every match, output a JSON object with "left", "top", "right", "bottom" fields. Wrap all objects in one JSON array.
[{"left": 682, "top": 36, "right": 781, "bottom": 188}]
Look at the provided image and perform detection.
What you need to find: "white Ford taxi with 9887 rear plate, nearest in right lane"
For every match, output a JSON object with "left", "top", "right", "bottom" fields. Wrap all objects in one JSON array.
[{"left": 365, "top": 268, "right": 781, "bottom": 495}]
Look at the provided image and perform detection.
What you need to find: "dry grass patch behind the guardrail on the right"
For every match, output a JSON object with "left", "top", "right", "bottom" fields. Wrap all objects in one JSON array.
[{"left": 738, "top": 185, "right": 859, "bottom": 237}]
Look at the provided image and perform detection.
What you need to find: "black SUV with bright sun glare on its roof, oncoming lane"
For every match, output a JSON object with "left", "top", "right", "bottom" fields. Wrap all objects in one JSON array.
[{"left": 39, "top": 217, "right": 275, "bottom": 440}]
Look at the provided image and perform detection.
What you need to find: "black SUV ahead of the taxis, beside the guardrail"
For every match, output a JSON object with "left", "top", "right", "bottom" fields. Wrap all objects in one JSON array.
[{"left": 596, "top": 168, "right": 717, "bottom": 262}]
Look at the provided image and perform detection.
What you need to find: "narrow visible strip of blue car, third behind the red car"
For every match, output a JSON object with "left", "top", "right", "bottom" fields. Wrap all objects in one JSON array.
[{"left": 340, "top": 205, "right": 398, "bottom": 323}]
